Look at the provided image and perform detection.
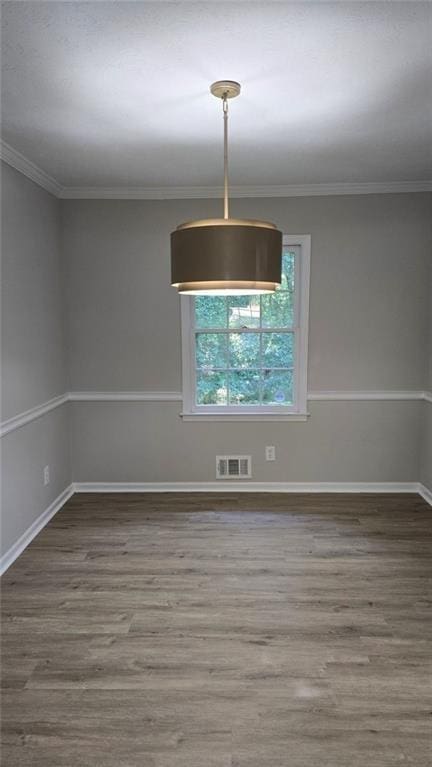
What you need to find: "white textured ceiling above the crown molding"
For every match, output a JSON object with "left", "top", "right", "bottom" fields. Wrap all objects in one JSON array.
[{"left": 2, "top": 1, "right": 432, "bottom": 187}]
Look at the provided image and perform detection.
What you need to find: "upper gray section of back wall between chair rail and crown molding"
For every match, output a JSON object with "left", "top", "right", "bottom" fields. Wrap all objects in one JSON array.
[{"left": 62, "top": 194, "right": 431, "bottom": 391}]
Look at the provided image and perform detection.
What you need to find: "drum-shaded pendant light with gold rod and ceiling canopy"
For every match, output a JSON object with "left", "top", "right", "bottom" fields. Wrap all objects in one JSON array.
[{"left": 171, "top": 80, "right": 282, "bottom": 296}]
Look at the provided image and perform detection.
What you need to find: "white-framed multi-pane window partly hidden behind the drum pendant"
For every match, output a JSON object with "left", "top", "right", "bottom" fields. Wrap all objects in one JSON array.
[{"left": 181, "top": 235, "right": 310, "bottom": 420}]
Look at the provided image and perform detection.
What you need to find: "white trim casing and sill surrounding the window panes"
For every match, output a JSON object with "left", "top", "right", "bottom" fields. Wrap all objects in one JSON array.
[{"left": 180, "top": 234, "right": 311, "bottom": 422}]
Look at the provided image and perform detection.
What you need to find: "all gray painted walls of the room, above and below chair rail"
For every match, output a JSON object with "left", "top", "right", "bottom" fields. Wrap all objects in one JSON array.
[{"left": 2, "top": 179, "right": 432, "bottom": 551}]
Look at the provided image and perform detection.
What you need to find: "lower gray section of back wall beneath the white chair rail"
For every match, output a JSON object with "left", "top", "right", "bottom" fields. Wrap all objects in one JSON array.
[{"left": 72, "top": 402, "right": 422, "bottom": 482}]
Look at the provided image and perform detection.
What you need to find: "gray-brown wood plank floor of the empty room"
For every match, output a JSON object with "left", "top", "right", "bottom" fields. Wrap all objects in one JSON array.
[{"left": 1, "top": 494, "right": 432, "bottom": 767}]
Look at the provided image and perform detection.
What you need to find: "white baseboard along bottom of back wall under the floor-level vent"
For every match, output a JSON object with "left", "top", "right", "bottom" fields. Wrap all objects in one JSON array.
[{"left": 74, "top": 480, "right": 420, "bottom": 493}]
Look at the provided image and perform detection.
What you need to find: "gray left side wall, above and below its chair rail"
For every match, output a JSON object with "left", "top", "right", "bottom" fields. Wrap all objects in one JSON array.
[{"left": 1, "top": 164, "right": 71, "bottom": 552}]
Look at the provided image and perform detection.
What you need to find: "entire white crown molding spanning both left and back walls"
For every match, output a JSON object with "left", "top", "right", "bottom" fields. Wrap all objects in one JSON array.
[{"left": 0, "top": 141, "right": 432, "bottom": 200}]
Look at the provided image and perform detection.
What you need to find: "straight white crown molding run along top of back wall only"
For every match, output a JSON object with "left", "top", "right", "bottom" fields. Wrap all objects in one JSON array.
[{"left": 60, "top": 180, "right": 432, "bottom": 200}]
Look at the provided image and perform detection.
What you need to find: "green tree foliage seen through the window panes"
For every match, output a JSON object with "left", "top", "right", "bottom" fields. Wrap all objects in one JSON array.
[{"left": 195, "top": 252, "right": 295, "bottom": 406}]
